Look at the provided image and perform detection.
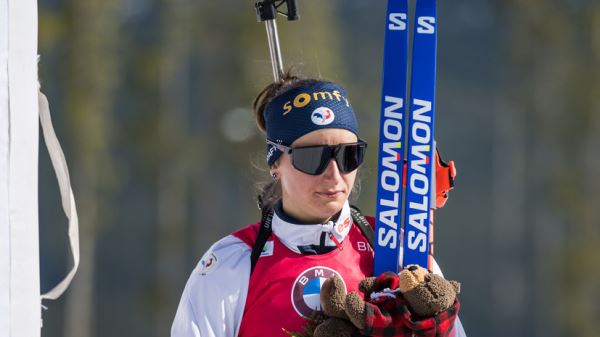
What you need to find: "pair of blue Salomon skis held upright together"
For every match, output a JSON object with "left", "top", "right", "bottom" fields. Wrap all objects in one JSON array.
[{"left": 374, "top": 0, "right": 437, "bottom": 275}]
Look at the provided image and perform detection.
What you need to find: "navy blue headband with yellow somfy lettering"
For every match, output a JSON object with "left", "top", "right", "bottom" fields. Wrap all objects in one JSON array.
[{"left": 264, "top": 82, "right": 358, "bottom": 166}]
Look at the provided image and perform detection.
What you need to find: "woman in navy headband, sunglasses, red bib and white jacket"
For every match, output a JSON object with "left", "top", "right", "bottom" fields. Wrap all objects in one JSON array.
[{"left": 172, "top": 74, "right": 462, "bottom": 337}]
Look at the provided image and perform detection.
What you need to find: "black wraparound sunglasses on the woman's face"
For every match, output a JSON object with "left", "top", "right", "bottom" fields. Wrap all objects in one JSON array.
[{"left": 267, "top": 140, "right": 367, "bottom": 176}]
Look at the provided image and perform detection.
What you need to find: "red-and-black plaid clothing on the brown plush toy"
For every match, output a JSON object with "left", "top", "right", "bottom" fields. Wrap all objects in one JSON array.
[{"left": 362, "top": 272, "right": 460, "bottom": 337}]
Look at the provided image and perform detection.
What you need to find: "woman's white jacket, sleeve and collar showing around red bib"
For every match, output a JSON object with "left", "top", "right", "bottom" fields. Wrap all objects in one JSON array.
[{"left": 171, "top": 203, "right": 466, "bottom": 337}]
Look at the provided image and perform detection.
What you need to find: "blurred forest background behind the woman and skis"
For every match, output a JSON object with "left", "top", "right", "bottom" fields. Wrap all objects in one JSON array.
[{"left": 38, "top": 0, "right": 600, "bottom": 337}]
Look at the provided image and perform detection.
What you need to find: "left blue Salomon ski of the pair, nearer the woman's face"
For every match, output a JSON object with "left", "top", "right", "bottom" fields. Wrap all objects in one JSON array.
[{"left": 374, "top": 0, "right": 408, "bottom": 275}]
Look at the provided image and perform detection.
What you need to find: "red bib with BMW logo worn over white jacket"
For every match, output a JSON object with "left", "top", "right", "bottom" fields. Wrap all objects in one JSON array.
[{"left": 233, "top": 224, "right": 373, "bottom": 337}]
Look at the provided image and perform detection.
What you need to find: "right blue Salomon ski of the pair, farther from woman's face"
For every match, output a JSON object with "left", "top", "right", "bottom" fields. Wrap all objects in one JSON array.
[{"left": 402, "top": 0, "right": 437, "bottom": 270}]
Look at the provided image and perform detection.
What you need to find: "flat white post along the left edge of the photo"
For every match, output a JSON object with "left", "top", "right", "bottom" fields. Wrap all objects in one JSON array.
[{"left": 0, "top": 0, "right": 41, "bottom": 337}]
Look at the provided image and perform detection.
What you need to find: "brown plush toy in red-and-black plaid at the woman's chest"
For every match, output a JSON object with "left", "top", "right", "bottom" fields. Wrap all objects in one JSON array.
[{"left": 292, "top": 265, "right": 460, "bottom": 337}]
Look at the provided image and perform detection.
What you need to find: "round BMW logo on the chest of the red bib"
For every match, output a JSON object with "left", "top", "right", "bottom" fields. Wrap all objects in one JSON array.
[{"left": 292, "top": 266, "right": 346, "bottom": 318}]
